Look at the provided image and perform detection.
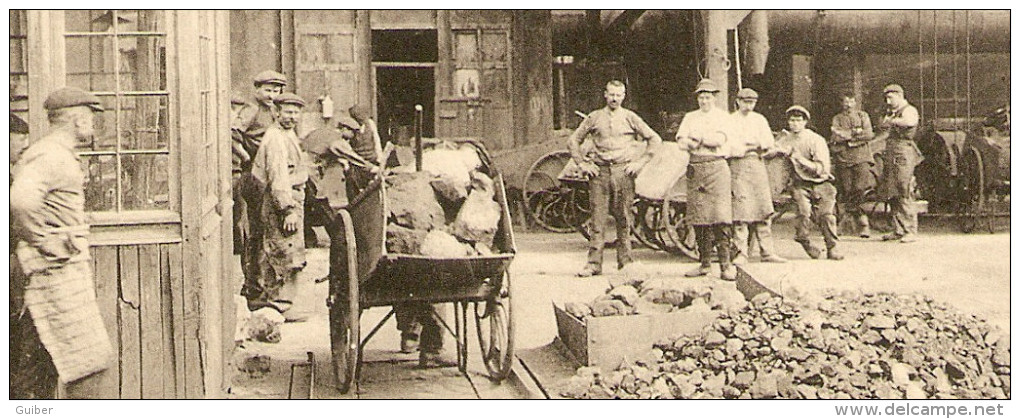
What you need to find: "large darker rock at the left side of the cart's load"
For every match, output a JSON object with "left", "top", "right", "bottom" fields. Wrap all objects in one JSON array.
[{"left": 386, "top": 172, "right": 446, "bottom": 231}]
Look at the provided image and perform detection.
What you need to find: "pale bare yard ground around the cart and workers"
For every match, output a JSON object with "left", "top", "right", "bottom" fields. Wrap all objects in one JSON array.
[{"left": 231, "top": 216, "right": 1010, "bottom": 399}]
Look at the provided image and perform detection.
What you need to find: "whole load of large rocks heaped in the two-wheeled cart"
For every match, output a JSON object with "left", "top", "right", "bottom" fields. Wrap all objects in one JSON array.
[{"left": 386, "top": 144, "right": 502, "bottom": 258}]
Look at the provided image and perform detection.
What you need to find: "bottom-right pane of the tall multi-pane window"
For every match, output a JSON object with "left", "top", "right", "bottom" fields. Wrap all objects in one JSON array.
[{"left": 120, "top": 154, "right": 170, "bottom": 211}]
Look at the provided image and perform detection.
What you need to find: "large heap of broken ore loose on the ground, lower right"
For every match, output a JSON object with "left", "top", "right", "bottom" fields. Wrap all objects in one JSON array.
[{"left": 562, "top": 292, "right": 1010, "bottom": 399}]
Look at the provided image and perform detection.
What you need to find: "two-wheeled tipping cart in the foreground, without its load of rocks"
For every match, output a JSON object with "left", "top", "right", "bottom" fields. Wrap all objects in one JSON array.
[{"left": 326, "top": 136, "right": 516, "bottom": 394}]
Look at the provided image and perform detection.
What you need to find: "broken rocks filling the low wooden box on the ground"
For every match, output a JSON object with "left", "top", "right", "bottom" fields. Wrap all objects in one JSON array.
[{"left": 563, "top": 280, "right": 738, "bottom": 320}]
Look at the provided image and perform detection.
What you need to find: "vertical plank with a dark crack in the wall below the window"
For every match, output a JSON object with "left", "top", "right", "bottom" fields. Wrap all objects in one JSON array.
[{"left": 117, "top": 246, "right": 142, "bottom": 399}]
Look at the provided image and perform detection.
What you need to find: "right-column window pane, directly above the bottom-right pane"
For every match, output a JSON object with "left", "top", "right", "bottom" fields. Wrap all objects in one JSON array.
[{"left": 119, "top": 96, "right": 169, "bottom": 150}]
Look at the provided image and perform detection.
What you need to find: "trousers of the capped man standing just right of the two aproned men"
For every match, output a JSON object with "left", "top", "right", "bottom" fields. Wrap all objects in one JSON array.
[{"left": 791, "top": 180, "right": 839, "bottom": 249}]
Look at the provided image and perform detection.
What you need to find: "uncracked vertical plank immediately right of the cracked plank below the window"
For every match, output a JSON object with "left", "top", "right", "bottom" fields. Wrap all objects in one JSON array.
[{"left": 138, "top": 245, "right": 163, "bottom": 399}]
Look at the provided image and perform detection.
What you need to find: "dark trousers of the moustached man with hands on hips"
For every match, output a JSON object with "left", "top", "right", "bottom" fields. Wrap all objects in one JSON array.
[{"left": 588, "top": 164, "right": 634, "bottom": 271}]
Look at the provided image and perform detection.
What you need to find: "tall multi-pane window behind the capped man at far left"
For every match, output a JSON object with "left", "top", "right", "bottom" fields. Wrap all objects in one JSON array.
[{"left": 64, "top": 10, "right": 171, "bottom": 212}]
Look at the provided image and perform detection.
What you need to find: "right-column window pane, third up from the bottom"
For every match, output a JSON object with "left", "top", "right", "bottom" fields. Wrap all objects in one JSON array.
[{"left": 117, "top": 36, "right": 166, "bottom": 92}]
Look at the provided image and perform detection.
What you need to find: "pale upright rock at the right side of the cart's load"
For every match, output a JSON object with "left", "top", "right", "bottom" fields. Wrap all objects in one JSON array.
[{"left": 451, "top": 171, "right": 503, "bottom": 248}]
